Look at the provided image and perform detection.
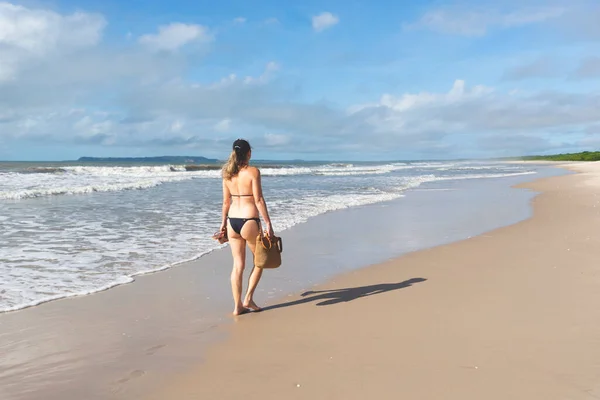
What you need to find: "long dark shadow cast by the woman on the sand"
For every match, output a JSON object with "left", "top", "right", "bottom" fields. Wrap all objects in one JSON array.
[{"left": 264, "top": 278, "right": 427, "bottom": 311}]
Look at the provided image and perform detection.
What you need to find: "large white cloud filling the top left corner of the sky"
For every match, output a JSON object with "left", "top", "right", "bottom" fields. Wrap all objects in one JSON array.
[{"left": 0, "top": 2, "right": 106, "bottom": 82}]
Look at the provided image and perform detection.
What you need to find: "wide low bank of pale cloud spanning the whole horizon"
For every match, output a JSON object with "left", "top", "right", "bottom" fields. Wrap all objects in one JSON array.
[{"left": 0, "top": 68, "right": 600, "bottom": 157}]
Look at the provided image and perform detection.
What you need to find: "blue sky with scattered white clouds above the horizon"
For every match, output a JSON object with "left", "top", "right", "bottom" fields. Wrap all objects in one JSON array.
[{"left": 0, "top": 0, "right": 600, "bottom": 160}]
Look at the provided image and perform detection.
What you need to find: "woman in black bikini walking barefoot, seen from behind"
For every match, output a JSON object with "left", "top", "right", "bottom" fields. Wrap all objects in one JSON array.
[{"left": 221, "top": 139, "right": 273, "bottom": 315}]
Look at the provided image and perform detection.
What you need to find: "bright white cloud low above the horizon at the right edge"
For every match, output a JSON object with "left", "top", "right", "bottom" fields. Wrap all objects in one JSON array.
[{"left": 342, "top": 80, "right": 600, "bottom": 155}]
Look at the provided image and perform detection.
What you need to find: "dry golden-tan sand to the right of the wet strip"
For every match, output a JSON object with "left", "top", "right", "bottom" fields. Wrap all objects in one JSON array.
[{"left": 148, "top": 163, "right": 600, "bottom": 400}]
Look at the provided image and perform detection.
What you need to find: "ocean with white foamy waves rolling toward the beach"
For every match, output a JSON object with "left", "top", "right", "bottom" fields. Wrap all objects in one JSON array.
[{"left": 0, "top": 161, "right": 536, "bottom": 312}]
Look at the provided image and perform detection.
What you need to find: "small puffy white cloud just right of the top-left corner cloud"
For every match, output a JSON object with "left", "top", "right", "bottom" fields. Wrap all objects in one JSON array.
[{"left": 139, "top": 23, "right": 213, "bottom": 51}]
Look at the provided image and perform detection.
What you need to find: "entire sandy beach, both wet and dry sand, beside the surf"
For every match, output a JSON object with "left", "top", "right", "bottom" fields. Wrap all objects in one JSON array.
[{"left": 0, "top": 164, "right": 600, "bottom": 400}]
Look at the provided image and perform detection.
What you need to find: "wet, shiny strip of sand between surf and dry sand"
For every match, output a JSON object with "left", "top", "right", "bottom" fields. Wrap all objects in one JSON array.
[{"left": 0, "top": 164, "right": 566, "bottom": 400}]
